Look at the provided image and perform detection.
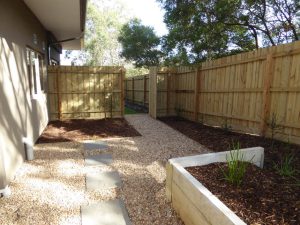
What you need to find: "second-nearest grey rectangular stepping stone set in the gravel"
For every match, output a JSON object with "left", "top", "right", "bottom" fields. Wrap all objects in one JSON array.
[{"left": 85, "top": 171, "right": 122, "bottom": 191}]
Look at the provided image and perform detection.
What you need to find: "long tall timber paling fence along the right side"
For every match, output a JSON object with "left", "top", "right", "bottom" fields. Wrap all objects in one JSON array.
[{"left": 149, "top": 41, "right": 300, "bottom": 143}]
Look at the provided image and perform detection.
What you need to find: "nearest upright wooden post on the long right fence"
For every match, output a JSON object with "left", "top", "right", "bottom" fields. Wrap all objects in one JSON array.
[{"left": 260, "top": 53, "right": 274, "bottom": 136}]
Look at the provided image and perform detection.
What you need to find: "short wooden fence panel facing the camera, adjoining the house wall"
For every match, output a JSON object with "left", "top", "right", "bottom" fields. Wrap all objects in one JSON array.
[{"left": 47, "top": 66, "right": 125, "bottom": 120}]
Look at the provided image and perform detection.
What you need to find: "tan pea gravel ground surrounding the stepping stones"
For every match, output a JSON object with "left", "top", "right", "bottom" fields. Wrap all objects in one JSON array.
[{"left": 0, "top": 114, "right": 207, "bottom": 225}]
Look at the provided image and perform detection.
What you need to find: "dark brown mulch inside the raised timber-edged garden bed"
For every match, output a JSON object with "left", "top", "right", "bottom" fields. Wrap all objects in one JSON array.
[{"left": 186, "top": 163, "right": 300, "bottom": 225}]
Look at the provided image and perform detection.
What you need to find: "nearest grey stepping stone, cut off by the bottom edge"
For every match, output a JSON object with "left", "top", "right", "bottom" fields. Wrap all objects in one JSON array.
[{"left": 81, "top": 200, "right": 131, "bottom": 225}]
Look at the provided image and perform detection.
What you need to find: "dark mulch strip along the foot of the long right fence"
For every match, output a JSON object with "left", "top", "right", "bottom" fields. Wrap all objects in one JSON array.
[{"left": 160, "top": 117, "right": 300, "bottom": 171}]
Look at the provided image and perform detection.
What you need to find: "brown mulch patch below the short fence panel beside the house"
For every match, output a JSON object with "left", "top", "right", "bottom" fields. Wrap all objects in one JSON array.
[{"left": 36, "top": 118, "right": 140, "bottom": 143}]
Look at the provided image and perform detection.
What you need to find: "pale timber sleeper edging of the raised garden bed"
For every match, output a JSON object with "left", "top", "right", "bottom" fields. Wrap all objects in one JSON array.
[{"left": 166, "top": 147, "right": 264, "bottom": 225}]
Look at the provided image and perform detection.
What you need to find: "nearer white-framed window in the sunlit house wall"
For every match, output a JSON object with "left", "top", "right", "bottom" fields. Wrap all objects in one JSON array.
[{"left": 26, "top": 48, "right": 45, "bottom": 96}]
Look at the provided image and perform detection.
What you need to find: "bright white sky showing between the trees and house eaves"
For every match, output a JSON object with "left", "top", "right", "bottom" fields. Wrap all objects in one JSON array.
[{"left": 61, "top": 0, "right": 168, "bottom": 65}]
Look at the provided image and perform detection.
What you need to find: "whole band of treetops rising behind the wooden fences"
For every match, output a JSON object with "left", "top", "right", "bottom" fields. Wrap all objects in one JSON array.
[{"left": 66, "top": 0, "right": 300, "bottom": 68}]
